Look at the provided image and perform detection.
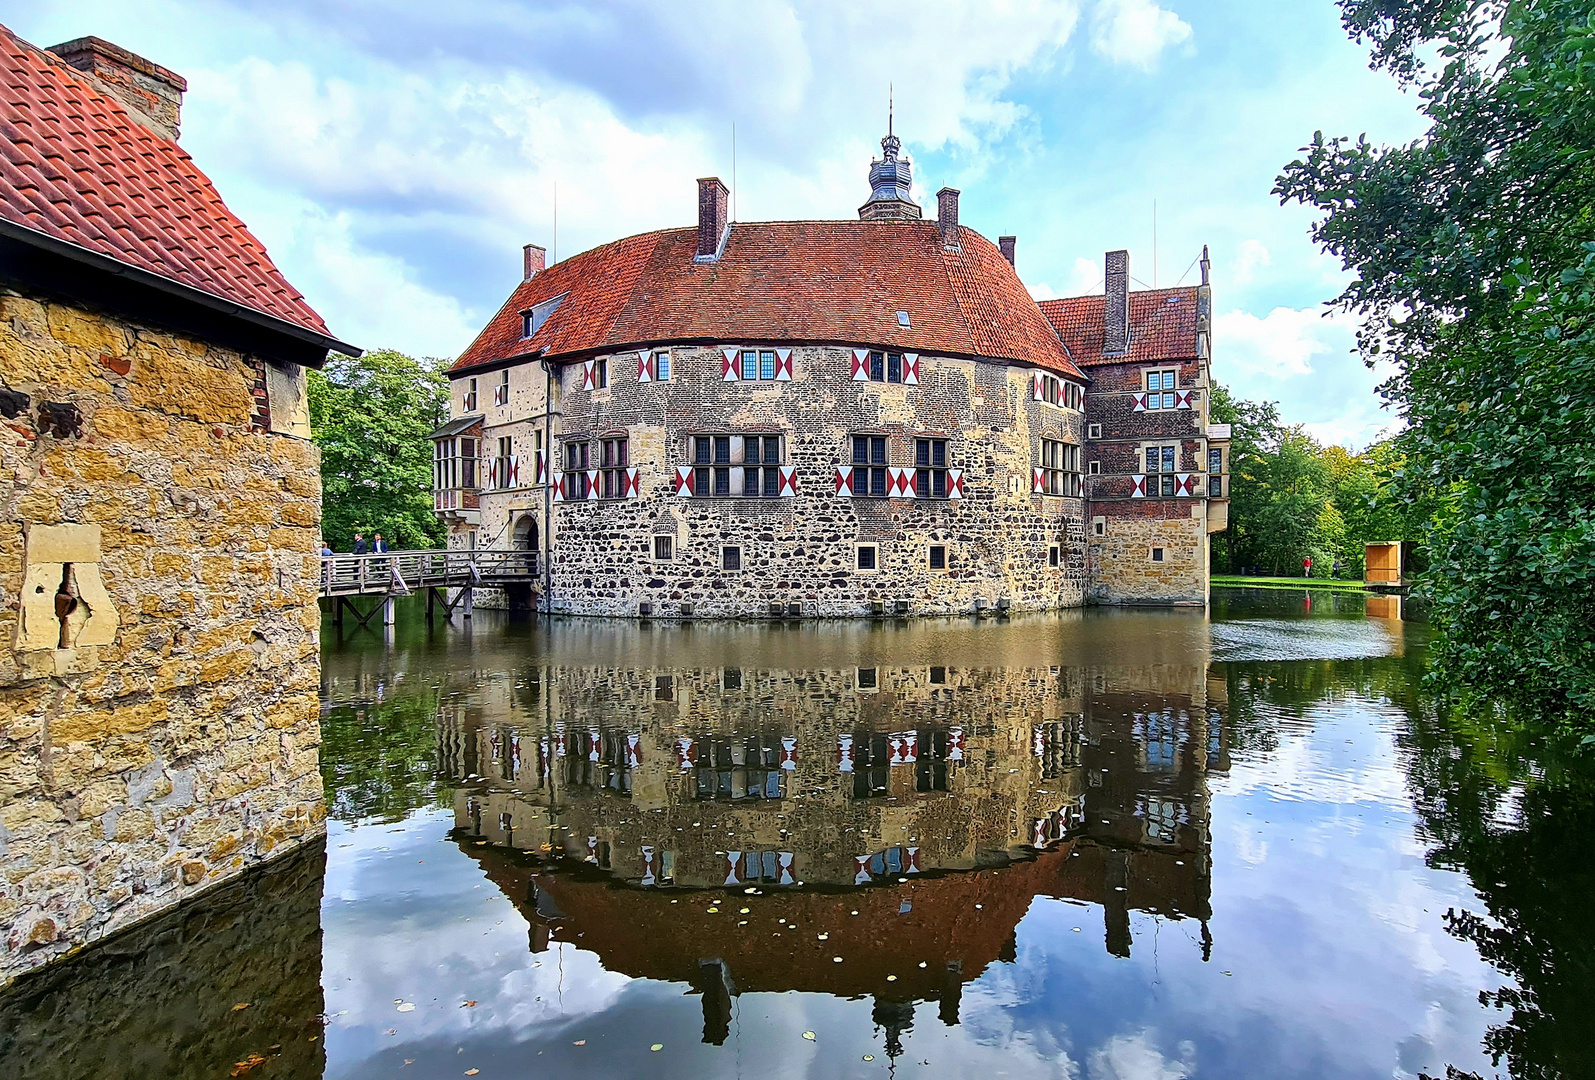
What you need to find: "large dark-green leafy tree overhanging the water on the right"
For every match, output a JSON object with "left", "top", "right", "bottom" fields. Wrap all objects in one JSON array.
[{"left": 1276, "top": 0, "right": 1595, "bottom": 724}]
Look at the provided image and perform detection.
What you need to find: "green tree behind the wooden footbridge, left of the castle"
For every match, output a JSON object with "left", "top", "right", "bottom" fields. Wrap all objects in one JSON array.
[{"left": 309, "top": 349, "right": 448, "bottom": 550}]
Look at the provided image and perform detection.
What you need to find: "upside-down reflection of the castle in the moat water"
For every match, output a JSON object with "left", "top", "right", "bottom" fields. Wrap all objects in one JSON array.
[{"left": 417, "top": 621, "right": 1228, "bottom": 1053}]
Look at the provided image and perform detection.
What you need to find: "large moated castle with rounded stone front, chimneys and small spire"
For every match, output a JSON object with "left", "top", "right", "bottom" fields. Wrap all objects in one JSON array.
[{"left": 434, "top": 126, "right": 1228, "bottom": 617}]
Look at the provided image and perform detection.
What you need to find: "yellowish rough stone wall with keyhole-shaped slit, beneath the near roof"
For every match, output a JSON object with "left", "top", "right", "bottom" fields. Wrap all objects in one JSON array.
[{"left": 0, "top": 290, "right": 324, "bottom": 981}]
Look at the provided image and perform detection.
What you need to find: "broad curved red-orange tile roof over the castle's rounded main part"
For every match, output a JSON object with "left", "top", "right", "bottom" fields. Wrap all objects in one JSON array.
[{"left": 455, "top": 222, "right": 1081, "bottom": 378}]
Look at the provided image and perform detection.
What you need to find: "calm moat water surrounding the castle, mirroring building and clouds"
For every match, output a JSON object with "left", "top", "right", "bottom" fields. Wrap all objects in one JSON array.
[{"left": 0, "top": 590, "right": 1595, "bottom": 1080}]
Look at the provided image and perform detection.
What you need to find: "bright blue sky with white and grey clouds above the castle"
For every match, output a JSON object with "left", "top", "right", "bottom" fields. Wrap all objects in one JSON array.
[{"left": 12, "top": 0, "right": 1421, "bottom": 445}]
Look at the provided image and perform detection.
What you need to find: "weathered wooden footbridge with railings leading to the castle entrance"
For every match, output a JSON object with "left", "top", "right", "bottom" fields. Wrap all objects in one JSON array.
[{"left": 321, "top": 549, "right": 541, "bottom": 627}]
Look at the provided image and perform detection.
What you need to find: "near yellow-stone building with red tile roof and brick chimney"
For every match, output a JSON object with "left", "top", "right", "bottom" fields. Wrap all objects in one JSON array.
[{"left": 0, "top": 27, "right": 352, "bottom": 981}]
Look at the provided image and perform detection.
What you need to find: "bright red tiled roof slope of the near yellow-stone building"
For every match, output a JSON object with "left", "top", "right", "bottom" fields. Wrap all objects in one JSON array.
[{"left": 0, "top": 26, "right": 336, "bottom": 335}]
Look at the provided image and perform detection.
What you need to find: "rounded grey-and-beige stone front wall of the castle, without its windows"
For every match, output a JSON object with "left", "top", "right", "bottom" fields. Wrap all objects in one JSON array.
[{"left": 542, "top": 346, "right": 1086, "bottom": 617}]
